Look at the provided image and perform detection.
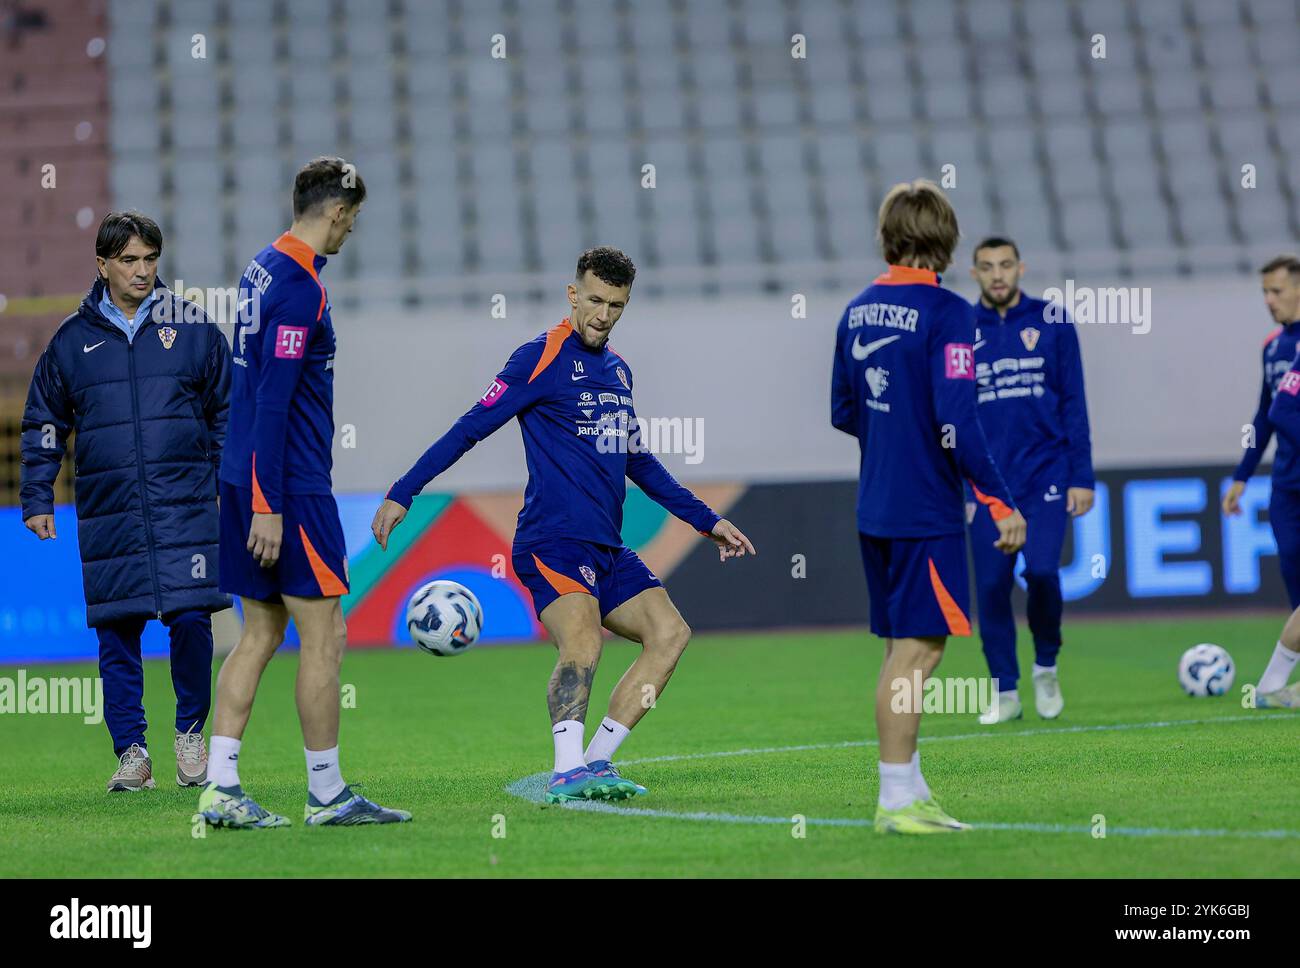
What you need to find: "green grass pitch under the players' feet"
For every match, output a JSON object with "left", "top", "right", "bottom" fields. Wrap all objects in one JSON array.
[{"left": 0, "top": 615, "right": 1300, "bottom": 877}]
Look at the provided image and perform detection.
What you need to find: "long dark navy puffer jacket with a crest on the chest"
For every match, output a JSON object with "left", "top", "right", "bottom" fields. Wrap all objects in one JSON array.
[{"left": 21, "top": 281, "right": 230, "bottom": 626}]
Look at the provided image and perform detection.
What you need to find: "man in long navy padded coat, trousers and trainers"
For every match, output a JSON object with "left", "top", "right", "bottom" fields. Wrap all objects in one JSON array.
[{"left": 21, "top": 212, "right": 230, "bottom": 791}]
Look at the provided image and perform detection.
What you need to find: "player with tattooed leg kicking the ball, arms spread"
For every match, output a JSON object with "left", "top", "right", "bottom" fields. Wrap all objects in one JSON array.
[{"left": 372, "top": 247, "right": 754, "bottom": 803}]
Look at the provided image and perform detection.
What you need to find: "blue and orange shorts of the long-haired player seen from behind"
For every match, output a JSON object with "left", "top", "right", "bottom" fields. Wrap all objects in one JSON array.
[{"left": 858, "top": 534, "right": 971, "bottom": 638}]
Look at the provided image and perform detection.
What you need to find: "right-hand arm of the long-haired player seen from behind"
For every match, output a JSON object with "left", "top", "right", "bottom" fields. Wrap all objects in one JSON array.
[{"left": 930, "top": 303, "right": 1024, "bottom": 554}]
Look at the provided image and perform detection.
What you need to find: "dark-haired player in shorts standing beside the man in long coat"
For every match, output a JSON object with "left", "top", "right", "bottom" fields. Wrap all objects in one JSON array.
[{"left": 199, "top": 159, "right": 411, "bottom": 828}]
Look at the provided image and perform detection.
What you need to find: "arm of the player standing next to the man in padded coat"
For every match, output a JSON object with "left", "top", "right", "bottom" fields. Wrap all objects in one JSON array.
[{"left": 247, "top": 282, "right": 321, "bottom": 568}]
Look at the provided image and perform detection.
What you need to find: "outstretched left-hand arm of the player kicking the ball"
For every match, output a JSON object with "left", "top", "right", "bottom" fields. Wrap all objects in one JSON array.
[{"left": 371, "top": 340, "right": 558, "bottom": 548}]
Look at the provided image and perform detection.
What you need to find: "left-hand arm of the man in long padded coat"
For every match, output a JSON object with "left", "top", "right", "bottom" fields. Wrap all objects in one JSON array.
[{"left": 18, "top": 347, "right": 73, "bottom": 541}]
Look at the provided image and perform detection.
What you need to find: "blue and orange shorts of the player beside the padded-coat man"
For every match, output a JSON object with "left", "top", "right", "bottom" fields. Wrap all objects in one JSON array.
[{"left": 221, "top": 481, "right": 347, "bottom": 604}]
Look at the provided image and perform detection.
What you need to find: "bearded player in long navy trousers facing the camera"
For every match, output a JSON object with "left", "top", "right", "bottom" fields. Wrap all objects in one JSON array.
[{"left": 970, "top": 236, "right": 1096, "bottom": 725}]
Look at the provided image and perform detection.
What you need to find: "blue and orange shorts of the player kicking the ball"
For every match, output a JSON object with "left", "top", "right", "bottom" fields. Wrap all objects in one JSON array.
[{"left": 511, "top": 539, "right": 663, "bottom": 618}]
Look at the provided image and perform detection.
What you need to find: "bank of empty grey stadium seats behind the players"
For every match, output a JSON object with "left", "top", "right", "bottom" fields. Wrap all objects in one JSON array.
[{"left": 86, "top": 0, "right": 1300, "bottom": 301}]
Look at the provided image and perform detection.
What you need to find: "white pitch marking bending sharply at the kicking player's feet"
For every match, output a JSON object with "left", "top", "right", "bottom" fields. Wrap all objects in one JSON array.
[{"left": 506, "top": 713, "right": 1300, "bottom": 839}]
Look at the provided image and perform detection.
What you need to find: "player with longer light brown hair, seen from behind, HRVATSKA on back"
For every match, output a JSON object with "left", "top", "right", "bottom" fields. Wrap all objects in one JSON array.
[{"left": 831, "top": 179, "right": 1024, "bottom": 834}]
